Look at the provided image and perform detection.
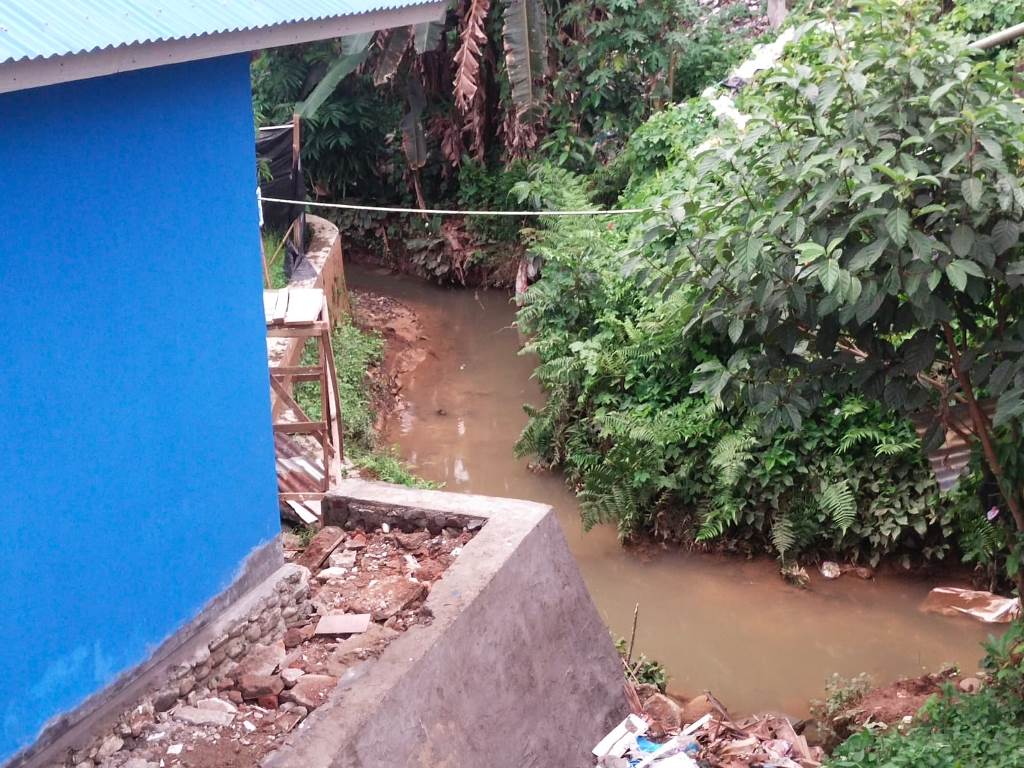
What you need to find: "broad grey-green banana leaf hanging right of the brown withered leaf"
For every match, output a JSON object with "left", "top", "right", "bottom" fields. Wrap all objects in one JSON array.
[{"left": 502, "top": 0, "right": 548, "bottom": 117}]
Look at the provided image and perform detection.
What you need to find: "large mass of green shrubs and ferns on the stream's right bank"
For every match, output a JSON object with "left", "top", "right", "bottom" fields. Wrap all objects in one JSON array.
[{"left": 520, "top": 2, "right": 1021, "bottom": 577}]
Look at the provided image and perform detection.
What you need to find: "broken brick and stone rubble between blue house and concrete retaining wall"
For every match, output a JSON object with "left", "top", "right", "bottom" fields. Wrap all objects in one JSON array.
[{"left": 61, "top": 526, "right": 473, "bottom": 768}]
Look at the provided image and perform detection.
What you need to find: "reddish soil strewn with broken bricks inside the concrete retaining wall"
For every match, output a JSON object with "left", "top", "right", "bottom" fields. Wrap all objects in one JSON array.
[{"left": 77, "top": 528, "right": 473, "bottom": 768}]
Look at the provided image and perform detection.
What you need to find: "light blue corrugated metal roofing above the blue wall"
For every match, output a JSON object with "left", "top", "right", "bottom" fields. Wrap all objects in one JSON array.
[{"left": 0, "top": 0, "right": 436, "bottom": 63}]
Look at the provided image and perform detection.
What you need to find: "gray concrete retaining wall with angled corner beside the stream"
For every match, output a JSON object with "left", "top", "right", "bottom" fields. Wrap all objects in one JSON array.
[{"left": 263, "top": 481, "right": 627, "bottom": 768}]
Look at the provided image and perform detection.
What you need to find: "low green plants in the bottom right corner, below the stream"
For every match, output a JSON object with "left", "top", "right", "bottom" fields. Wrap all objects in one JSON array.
[{"left": 826, "top": 623, "right": 1024, "bottom": 768}]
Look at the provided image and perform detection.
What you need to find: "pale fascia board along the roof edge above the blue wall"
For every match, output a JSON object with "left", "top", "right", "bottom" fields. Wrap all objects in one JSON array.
[{"left": 0, "top": 0, "right": 447, "bottom": 93}]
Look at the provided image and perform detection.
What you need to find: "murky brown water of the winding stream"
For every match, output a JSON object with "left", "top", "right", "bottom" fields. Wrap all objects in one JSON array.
[{"left": 348, "top": 267, "right": 990, "bottom": 716}]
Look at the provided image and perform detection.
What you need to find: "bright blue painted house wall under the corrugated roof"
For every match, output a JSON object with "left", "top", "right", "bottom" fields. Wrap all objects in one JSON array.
[{"left": 0, "top": 55, "right": 279, "bottom": 763}]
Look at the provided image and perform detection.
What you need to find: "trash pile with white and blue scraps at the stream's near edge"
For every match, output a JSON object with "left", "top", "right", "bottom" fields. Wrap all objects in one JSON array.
[{"left": 593, "top": 684, "right": 824, "bottom": 768}]
